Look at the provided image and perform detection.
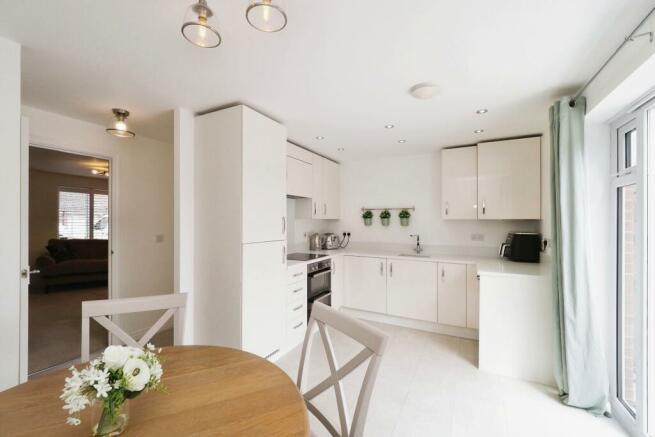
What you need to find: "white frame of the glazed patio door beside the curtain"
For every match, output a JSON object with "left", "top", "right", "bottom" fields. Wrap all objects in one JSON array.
[{"left": 610, "top": 104, "right": 655, "bottom": 436}]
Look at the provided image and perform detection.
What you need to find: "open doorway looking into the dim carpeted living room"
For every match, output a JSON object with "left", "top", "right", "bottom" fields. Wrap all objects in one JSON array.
[{"left": 27, "top": 146, "right": 111, "bottom": 376}]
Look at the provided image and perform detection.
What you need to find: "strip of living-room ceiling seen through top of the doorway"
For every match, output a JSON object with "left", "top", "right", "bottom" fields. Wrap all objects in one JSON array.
[{"left": 30, "top": 147, "right": 109, "bottom": 179}]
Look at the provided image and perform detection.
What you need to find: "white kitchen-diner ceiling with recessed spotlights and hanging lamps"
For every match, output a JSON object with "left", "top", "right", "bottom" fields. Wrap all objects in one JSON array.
[{"left": 0, "top": 0, "right": 654, "bottom": 160}]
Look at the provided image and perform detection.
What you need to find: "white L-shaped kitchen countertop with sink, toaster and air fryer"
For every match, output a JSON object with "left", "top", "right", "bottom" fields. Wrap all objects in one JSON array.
[{"left": 287, "top": 244, "right": 550, "bottom": 276}]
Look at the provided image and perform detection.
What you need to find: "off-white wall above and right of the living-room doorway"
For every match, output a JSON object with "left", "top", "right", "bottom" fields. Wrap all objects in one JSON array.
[{"left": 22, "top": 106, "right": 173, "bottom": 335}]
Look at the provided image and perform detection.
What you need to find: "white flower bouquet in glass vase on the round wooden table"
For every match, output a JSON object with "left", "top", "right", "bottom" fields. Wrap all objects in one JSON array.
[{"left": 60, "top": 344, "right": 163, "bottom": 436}]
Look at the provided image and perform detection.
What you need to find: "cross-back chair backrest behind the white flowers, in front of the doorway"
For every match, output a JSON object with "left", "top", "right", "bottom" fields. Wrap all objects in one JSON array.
[{"left": 82, "top": 293, "right": 186, "bottom": 362}]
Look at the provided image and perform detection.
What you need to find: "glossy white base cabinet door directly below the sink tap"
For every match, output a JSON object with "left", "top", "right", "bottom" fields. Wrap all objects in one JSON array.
[{"left": 387, "top": 259, "right": 437, "bottom": 323}]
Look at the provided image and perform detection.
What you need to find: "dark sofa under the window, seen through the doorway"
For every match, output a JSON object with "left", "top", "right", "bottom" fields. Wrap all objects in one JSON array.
[{"left": 36, "top": 238, "right": 109, "bottom": 291}]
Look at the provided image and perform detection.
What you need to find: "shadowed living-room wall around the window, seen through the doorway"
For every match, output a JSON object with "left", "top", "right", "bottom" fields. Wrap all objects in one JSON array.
[{"left": 29, "top": 170, "right": 109, "bottom": 266}]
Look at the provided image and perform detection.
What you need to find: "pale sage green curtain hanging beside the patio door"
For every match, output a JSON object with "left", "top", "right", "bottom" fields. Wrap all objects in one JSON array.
[{"left": 550, "top": 98, "right": 609, "bottom": 414}]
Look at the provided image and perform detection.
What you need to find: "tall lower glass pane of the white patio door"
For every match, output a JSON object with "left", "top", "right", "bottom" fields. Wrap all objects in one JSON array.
[{"left": 617, "top": 184, "right": 639, "bottom": 415}]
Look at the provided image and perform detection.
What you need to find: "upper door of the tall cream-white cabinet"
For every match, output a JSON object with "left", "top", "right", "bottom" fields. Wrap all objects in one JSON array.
[{"left": 241, "top": 107, "right": 287, "bottom": 243}]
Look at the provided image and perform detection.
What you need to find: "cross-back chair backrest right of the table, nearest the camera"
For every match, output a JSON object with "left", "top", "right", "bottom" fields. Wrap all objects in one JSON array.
[{"left": 297, "top": 302, "right": 388, "bottom": 437}]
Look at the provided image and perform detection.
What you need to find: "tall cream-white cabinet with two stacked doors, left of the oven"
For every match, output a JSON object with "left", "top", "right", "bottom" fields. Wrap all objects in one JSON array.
[{"left": 193, "top": 106, "right": 287, "bottom": 358}]
